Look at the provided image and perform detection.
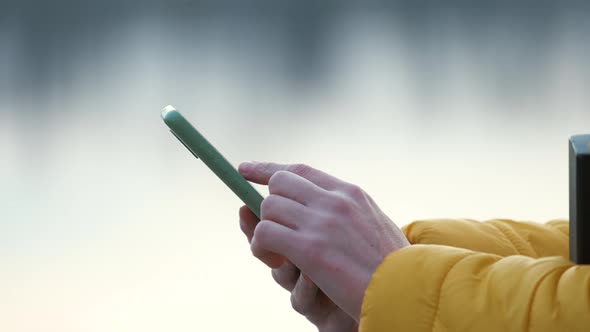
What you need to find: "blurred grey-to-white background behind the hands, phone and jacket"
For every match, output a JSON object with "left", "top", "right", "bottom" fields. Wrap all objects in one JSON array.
[{"left": 0, "top": 0, "right": 590, "bottom": 332}]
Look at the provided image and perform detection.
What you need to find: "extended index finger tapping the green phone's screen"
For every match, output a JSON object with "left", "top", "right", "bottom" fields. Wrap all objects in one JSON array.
[{"left": 238, "top": 162, "right": 345, "bottom": 191}]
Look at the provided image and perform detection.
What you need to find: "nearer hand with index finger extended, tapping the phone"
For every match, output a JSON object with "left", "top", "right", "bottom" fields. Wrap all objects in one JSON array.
[{"left": 239, "top": 163, "right": 409, "bottom": 322}]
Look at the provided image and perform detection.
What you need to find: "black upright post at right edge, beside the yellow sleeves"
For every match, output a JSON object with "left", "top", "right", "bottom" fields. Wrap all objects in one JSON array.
[{"left": 569, "top": 134, "right": 590, "bottom": 264}]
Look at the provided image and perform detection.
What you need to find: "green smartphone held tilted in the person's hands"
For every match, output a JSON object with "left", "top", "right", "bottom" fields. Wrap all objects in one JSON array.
[{"left": 162, "top": 105, "right": 263, "bottom": 219}]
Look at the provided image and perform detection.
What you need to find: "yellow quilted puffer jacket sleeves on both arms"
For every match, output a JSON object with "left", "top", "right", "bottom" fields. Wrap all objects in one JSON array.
[{"left": 359, "top": 219, "right": 590, "bottom": 332}]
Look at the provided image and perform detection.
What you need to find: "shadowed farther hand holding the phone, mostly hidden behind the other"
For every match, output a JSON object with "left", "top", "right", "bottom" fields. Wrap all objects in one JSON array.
[{"left": 240, "top": 206, "right": 358, "bottom": 332}]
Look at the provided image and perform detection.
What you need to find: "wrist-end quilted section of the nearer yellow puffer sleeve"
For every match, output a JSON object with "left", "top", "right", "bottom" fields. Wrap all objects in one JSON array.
[{"left": 359, "top": 245, "right": 474, "bottom": 332}]
